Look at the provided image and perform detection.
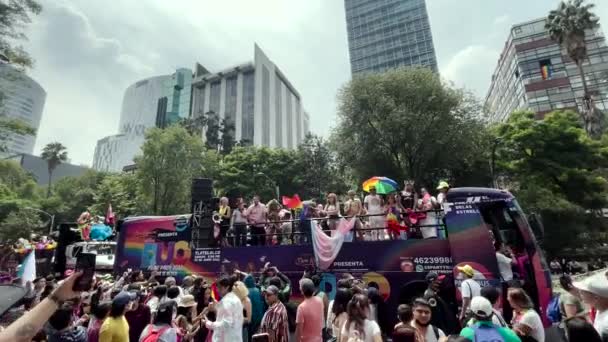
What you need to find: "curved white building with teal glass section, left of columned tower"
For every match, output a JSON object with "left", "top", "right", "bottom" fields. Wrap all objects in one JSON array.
[{"left": 93, "top": 68, "right": 192, "bottom": 172}]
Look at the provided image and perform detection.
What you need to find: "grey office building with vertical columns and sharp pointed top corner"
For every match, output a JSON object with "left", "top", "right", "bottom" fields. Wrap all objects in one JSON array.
[{"left": 191, "top": 44, "right": 310, "bottom": 148}]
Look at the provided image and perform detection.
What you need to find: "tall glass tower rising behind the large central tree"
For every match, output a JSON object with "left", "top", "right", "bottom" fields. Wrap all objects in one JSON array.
[{"left": 344, "top": 0, "right": 437, "bottom": 75}]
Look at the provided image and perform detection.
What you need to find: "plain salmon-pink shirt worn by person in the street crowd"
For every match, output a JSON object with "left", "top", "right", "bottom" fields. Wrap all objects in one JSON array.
[{"left": 296, "top": 296, "right": 324, "bottom": 342}]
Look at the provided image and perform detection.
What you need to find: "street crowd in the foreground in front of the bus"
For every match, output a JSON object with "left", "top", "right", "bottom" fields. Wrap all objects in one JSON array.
[{"left": 0, "top": 264, "right": 608, "bottom": 342}]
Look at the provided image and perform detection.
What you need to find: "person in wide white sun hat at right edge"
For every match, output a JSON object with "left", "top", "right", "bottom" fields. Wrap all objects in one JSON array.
[{"left": 572, "top": 274, "right": 608, "bottom": 341}]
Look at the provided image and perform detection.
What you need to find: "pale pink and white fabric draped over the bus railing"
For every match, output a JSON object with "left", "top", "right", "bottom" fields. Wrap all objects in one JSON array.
[{"left": 311, "top": 218, "right": 357, "bottom": 270}]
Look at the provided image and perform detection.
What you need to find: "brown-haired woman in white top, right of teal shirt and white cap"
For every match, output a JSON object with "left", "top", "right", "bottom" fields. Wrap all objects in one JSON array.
[{"left": 507, "top": 288, "right": 545, "bottom": 342}]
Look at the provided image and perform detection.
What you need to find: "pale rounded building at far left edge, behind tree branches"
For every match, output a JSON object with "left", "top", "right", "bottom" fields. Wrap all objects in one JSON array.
[{"left": 0, "top": 60, "right": 46, "bottom": 157}]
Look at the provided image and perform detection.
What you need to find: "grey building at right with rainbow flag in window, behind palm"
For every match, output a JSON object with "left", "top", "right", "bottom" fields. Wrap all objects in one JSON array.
[{"left": 484, "top": 18, "right": 608, "bottom": 122}]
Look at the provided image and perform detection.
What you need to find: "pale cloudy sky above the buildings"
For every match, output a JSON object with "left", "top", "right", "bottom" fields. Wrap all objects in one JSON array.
[{"left": 21, "top": 0, "right": 608, "bottom": 165}]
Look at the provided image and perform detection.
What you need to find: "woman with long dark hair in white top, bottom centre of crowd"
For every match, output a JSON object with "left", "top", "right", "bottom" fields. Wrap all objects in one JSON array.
[{"left": 339, "top": 294, "right": 382, "bottom": 342}]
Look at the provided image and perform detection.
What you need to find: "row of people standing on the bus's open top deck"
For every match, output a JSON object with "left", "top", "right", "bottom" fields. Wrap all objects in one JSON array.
[{"left": 214, "top": 182, "right": 449, "bottom": 246}]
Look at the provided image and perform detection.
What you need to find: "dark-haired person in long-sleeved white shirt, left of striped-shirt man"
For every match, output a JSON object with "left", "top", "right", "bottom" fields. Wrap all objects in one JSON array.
[{"left": 203, "top": 276, "right": 243, "bottom": 342}]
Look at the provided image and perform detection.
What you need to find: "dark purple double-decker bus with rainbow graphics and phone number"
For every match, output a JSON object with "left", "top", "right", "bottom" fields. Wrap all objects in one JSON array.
[{"left": 114, "top": 188, "right": 552, "bottom": 332}]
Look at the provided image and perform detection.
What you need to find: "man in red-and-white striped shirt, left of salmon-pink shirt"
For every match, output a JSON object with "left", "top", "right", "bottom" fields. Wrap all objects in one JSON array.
[{"left": 260, "top": 285, "right": 289, "bottom": 342}]
